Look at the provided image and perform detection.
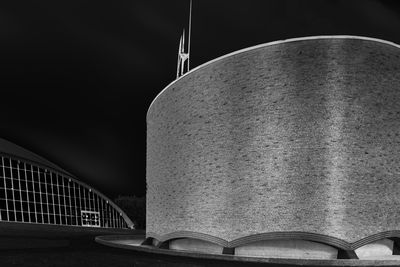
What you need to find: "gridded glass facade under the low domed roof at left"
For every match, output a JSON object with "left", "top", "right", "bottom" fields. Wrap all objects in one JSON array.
[{"left": 0, "top": 156, "right": 129, "bottom": 228}]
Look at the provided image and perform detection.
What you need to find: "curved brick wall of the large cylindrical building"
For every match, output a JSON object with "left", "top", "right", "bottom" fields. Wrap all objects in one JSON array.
[{"left": 146, "top": 38, "right": 400, "bottom": 247}]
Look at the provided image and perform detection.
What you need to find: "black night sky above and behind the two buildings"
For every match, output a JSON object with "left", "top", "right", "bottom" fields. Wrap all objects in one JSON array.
[{"left": 0, "top": 0, "right": 400, "bottom": 197}]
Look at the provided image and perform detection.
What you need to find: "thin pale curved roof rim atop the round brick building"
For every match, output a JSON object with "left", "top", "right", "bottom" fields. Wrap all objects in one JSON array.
[{"left": 147, "top": 35, "right": 400, "bottom": 118}]
